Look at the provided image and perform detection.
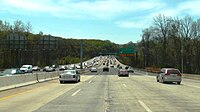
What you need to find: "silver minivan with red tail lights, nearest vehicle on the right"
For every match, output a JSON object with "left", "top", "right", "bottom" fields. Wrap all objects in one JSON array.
[{"left": 156, "top": 68, "right": 182, "bottom": 84}]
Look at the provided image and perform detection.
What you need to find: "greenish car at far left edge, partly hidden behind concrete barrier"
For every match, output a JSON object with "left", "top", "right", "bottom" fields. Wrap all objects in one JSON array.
[{"left": 0, "top": 68, "right": 24, "bottom": 76}]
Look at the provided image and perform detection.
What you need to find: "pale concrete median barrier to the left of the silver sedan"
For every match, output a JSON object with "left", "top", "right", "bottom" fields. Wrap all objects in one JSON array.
[{"left": 0, "top": 71, "right": 60, "bottom": 91}]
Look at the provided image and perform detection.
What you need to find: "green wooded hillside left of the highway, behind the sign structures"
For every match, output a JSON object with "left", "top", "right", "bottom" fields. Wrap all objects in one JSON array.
[{"left": 0, "top": 20, "right": 119, "bottom": 68}]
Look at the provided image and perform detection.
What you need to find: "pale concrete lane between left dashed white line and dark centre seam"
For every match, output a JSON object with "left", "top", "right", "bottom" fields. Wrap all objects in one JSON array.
[{"left": 35, "top": 75, "right": 108, "bottom": 112}]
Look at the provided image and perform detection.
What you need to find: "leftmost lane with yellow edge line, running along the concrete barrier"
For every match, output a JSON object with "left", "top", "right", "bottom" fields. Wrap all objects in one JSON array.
[{"left": 0, "top": 76, "right": 94, "bottom": 112}]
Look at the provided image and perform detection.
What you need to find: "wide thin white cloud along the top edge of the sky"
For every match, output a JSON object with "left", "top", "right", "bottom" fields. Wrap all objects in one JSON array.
[{"left": 0, "top": 0, "right": 163, "bottom": 19}]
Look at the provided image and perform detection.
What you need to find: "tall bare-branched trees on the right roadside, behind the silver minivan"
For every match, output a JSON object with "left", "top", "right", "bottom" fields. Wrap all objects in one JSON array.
[{"left": 136, "top": 14, "right": 200, "bottom": 73}]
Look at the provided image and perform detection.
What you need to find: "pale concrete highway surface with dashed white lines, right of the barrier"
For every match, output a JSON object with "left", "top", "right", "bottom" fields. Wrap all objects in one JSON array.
[{"left": 0, "top": 66, "right": 200, "bottom": 112}]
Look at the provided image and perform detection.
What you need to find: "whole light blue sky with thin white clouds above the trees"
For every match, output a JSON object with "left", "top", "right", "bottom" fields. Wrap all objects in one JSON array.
[{"left": 0, "top": 0, "right": 200, "bottom": 44}]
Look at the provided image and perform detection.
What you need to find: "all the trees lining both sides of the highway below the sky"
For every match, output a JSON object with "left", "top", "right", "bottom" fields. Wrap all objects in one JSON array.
[{"left": 0, "top": 14, "right": 200, "bottom": 73}]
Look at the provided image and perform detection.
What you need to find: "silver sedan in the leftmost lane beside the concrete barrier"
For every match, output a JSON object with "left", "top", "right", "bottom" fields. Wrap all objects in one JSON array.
[{"left": 59, "top": 70, "right": 81, "bottom": 83}]
